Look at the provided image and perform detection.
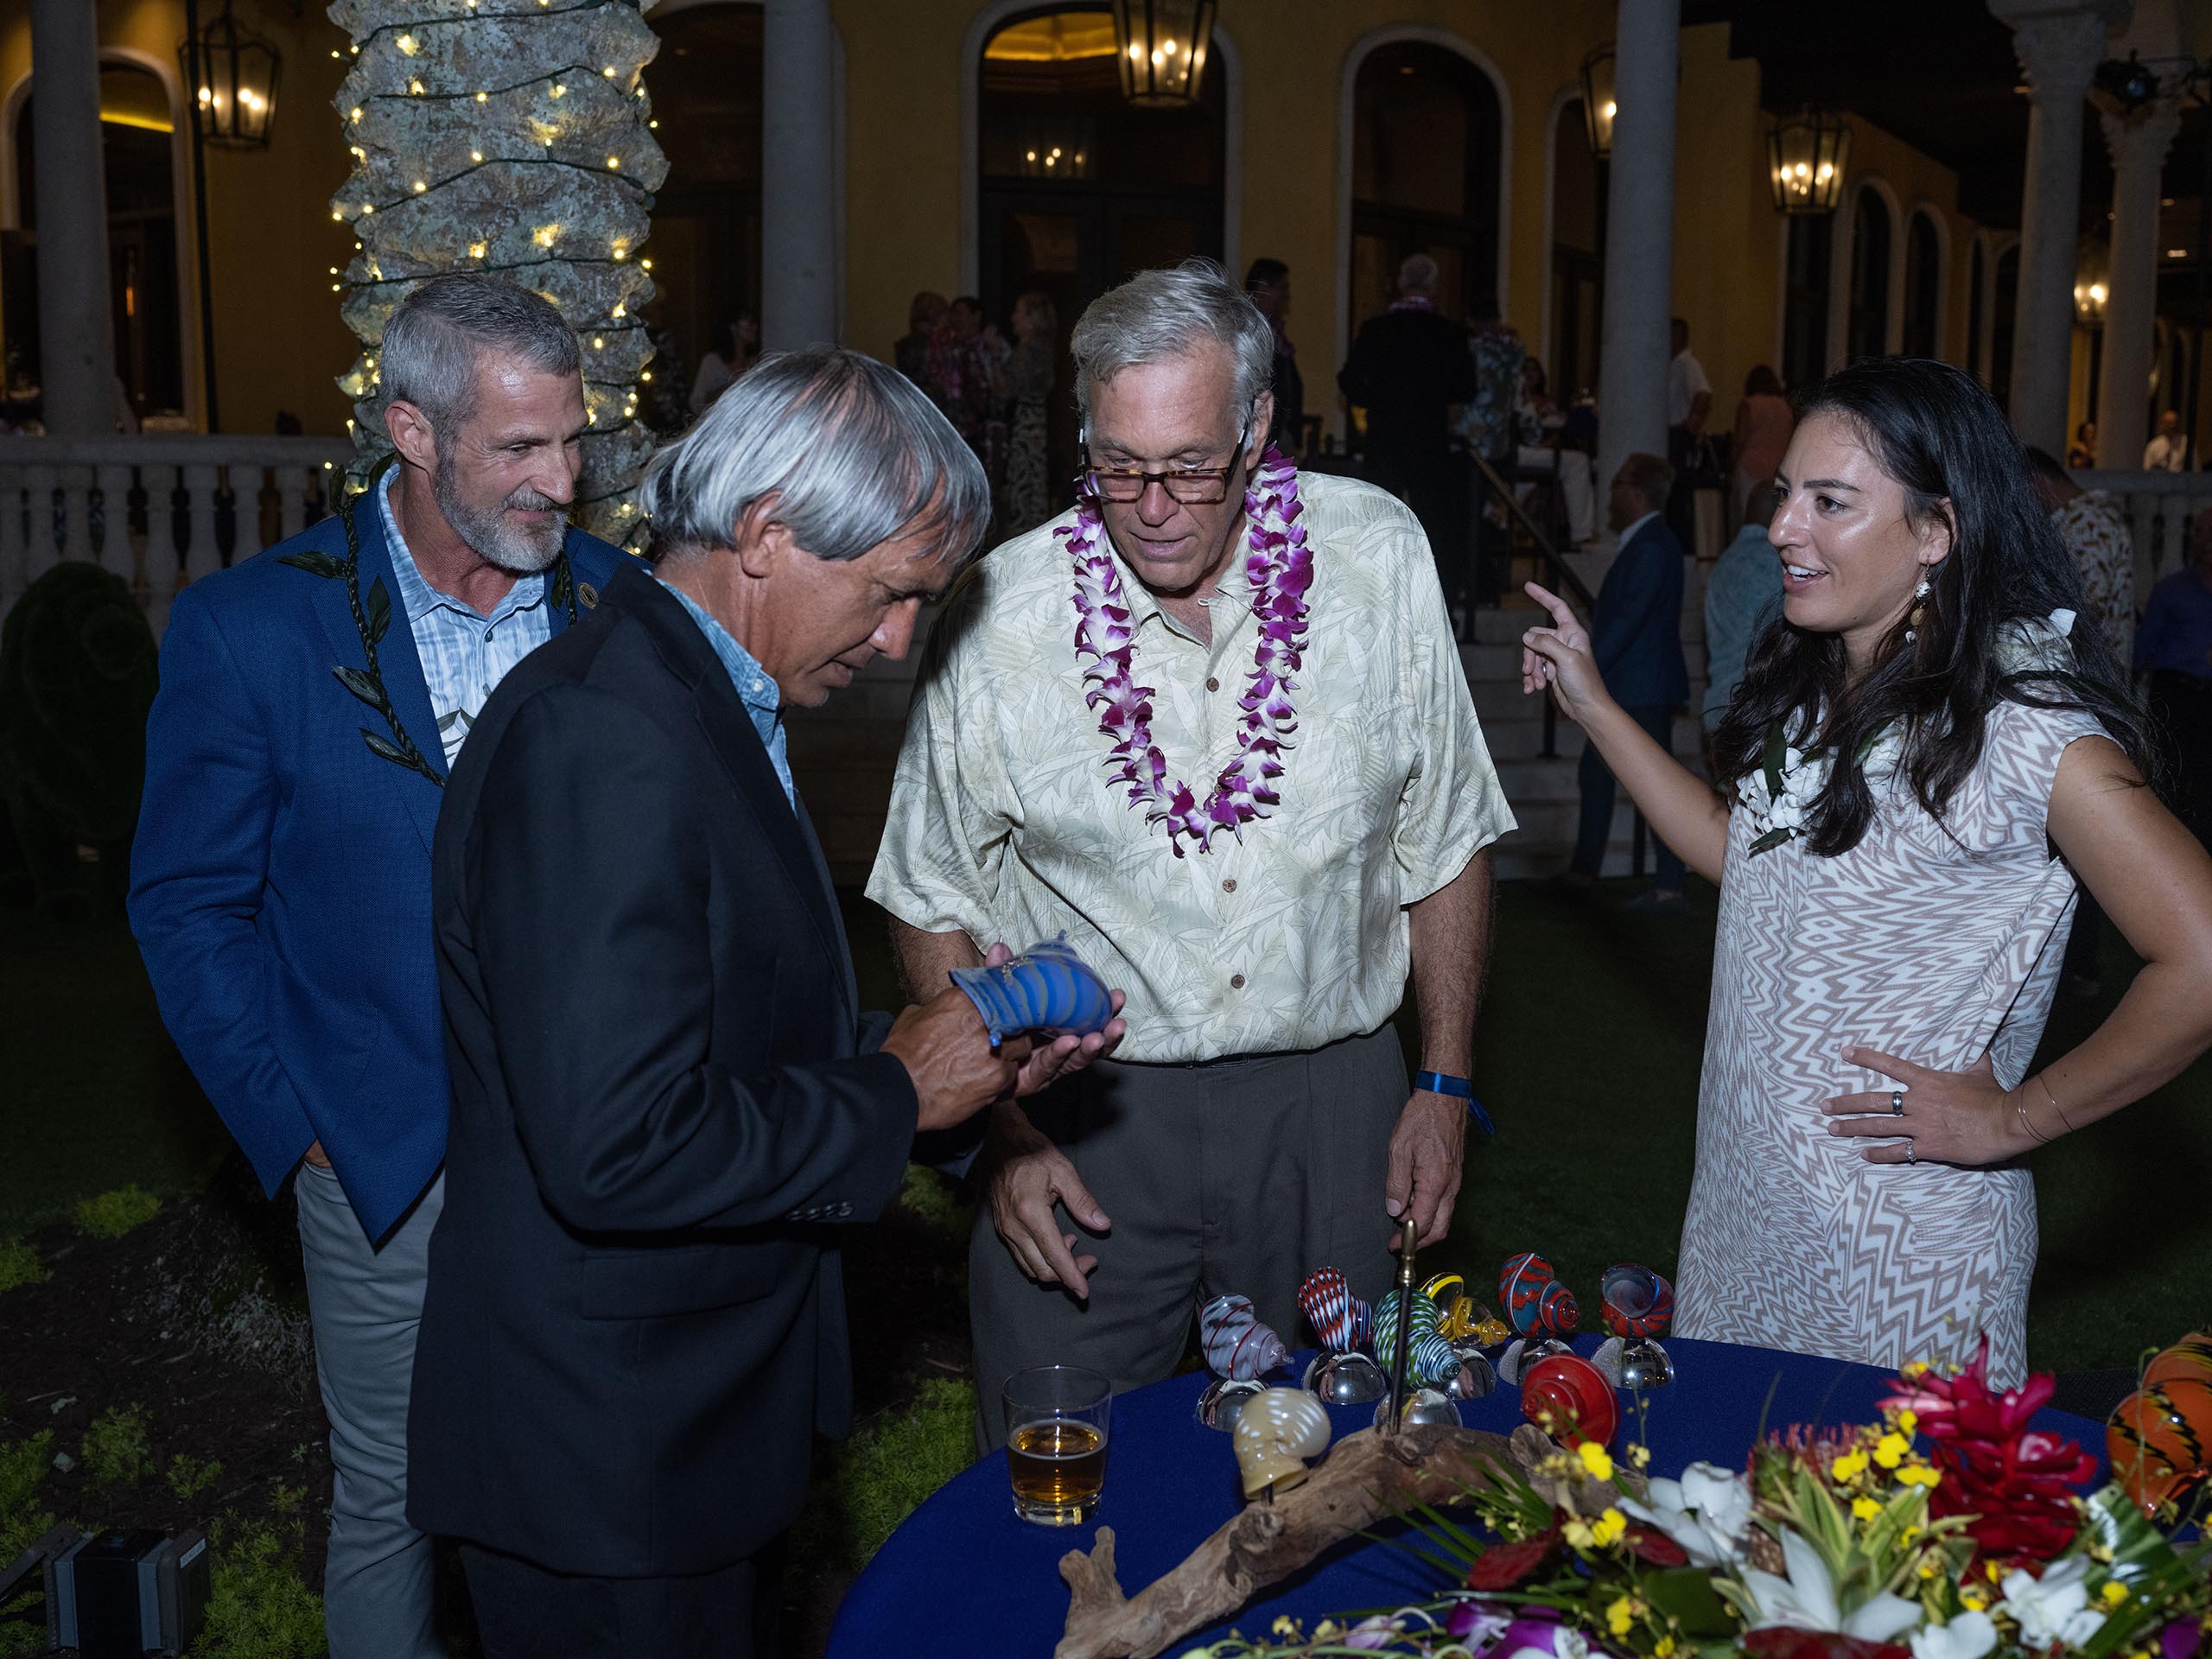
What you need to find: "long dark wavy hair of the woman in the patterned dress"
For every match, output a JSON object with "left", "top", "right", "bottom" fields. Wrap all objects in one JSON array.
[{"left": 1712, "top": 359, "right": 2150, "bottom": 856}]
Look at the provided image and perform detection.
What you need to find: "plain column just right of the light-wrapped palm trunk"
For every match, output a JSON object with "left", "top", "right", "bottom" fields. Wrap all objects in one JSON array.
[{"left": 761, "top": 0, "right": 838, "bottom": 352}]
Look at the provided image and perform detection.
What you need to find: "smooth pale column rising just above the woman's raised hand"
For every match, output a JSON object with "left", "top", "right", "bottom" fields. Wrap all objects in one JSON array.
[{"left": 1597, "top": 0, "right": 1681, "bottom": 512}]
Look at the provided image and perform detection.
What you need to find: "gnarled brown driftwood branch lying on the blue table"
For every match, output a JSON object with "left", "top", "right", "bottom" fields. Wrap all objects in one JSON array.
[{"left": 1053, "top": 1425, "right": 1608, "bottom": 1659}]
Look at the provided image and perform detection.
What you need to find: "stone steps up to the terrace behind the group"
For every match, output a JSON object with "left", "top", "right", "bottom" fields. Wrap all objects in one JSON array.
[{"left": 790, "top": 556, "right": 1706, "bottom": 887}]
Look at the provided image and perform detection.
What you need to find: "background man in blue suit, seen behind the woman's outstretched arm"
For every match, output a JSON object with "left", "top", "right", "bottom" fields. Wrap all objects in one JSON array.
[{"left": 1566, "top": 454, "right": 1690, "bottom": 905}]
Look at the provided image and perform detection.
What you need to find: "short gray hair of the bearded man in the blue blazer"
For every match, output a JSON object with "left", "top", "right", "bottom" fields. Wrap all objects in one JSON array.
[{"left": 376, "top": 272, "right": 584, "bottom": 442}]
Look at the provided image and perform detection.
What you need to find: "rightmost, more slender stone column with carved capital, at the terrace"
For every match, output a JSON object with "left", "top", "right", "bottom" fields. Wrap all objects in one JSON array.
[{"left": 2096, "top": 98, "right": 2181, "bottom": 471}]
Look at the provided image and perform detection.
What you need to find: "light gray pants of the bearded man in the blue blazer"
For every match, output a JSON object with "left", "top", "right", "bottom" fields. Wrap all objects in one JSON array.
[{"left": 292, "top": 1164, "right": 445, "bottom": 1659}]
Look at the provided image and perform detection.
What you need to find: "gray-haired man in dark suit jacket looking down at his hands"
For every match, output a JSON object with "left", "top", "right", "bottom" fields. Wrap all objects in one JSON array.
[{"left": 410, "top": 349, "right": 1119, "bottom": 1659}]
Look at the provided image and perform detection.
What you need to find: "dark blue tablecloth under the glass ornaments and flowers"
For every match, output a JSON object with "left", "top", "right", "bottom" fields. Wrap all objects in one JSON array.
[{"left": 830, "top": 1336, "right": 2104, "bottom": 1659}]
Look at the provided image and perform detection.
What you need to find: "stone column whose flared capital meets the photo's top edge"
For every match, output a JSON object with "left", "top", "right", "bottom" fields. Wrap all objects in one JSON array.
[{"left": 1988, "top": 0, "right": 2133, "bottom": 455}]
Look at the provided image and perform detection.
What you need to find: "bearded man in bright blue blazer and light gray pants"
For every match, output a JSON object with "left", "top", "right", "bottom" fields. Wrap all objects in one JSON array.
[{"left": 130, "top": 274, "right": 632, "bottom": 1659}]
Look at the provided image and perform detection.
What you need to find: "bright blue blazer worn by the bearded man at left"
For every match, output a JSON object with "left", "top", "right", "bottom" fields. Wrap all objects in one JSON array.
[{"left": 130, "top": 495, "right": 632, "bottom": 1239}]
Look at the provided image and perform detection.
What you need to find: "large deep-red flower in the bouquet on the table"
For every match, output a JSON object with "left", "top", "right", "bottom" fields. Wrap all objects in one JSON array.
[{"left": 1883, "top": 1336, "right": 2097, "bottom": 1561}]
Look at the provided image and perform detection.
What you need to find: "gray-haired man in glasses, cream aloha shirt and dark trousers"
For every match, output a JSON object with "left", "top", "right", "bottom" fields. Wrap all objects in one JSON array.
[{"left": 868, "top": 261, "right": 1513, "bottom": 1445}]
